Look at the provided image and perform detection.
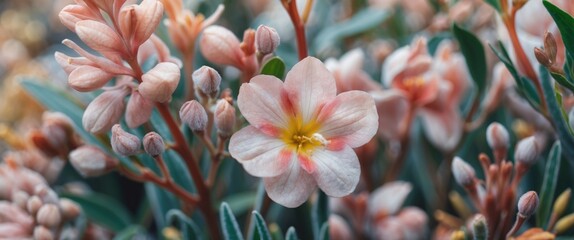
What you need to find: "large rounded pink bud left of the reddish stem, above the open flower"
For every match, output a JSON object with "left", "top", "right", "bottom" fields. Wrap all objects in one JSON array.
[{"left": 199, "top": 26, "right": 243, "bottom": 68}]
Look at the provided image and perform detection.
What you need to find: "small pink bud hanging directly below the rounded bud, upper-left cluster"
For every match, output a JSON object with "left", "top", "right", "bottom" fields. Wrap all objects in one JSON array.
[{"left": 126, "top": 90, "right": 154, "bottom": 128}]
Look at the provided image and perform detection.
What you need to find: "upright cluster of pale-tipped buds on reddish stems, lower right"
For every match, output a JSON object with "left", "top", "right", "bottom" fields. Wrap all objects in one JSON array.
[{"left": 448, "top": 122, "right": 546, "bottom": 239}]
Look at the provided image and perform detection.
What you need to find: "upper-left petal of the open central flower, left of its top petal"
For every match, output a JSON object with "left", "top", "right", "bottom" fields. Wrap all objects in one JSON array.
[{"left": 237, "top": 75, "right": 288, "bottom": 128}]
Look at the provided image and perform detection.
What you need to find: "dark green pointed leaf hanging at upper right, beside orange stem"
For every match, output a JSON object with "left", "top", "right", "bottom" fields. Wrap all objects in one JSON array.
[{"left": 452, "top": 23, "right": 487, "bottom": 96}]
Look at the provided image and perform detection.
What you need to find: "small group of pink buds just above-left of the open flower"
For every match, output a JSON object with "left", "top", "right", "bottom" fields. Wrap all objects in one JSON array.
[{"left": 199, "top": 25, "right": 279, "bottom": 82}]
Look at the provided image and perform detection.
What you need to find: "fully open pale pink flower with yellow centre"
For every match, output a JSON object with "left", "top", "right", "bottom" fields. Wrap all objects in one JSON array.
[{"left": 229, "top": 57, "right": 378, "bottom": 207}]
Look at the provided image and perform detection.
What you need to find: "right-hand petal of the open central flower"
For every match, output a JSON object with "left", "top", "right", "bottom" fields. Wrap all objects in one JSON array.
[{"left": 317, "top": 91, "right": 379, "bottom": 148}]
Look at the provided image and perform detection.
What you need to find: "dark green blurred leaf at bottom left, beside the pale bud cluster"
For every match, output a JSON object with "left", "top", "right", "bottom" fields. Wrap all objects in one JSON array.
[{"left": 60, "top": 193, "right": 132, "bottom": 232}]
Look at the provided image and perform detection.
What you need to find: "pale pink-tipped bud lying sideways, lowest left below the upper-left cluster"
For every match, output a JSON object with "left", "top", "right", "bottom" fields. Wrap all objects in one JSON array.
[{"left": 69, "top": 145, "right": 119, "bottom": 177}]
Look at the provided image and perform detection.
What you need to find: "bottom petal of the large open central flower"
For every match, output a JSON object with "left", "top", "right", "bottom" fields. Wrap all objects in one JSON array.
[{"left": 263, "top": 161, "right": 317, "bottom": 208}]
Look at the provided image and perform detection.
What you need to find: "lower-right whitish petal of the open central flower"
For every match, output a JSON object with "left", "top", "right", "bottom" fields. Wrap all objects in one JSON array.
[{"left": 311, "top": 146, "right": 361, "bottom": 197}]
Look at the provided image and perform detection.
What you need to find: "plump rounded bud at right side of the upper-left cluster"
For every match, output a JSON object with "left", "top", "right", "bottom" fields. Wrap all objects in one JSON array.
[{"left": 138, "top": 62, "right": 180, "bottom": 103}]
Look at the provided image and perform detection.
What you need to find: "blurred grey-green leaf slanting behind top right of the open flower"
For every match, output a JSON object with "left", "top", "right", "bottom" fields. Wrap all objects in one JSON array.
[{"left": 313, "top": 8, "right": 391, "bottom": 52}]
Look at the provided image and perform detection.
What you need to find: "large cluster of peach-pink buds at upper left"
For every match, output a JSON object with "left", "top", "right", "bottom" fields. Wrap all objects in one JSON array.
[{"left": 55, "top": 0, "right": 181, "bottom": 133}]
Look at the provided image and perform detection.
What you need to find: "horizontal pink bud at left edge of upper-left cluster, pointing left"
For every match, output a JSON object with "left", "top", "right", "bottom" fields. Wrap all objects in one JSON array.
[{"left": 68, "top": 65, "right": 114, "bottom": 92}]
